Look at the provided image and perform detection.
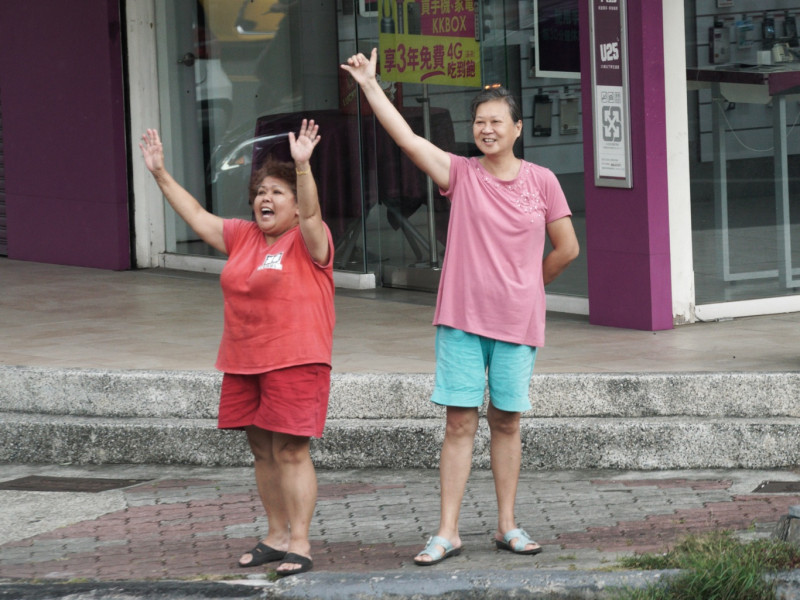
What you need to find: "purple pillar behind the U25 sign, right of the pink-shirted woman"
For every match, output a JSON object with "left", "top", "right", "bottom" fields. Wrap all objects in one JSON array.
[{"left": 580, "top": 0, "right": 673, "bottom": 330}]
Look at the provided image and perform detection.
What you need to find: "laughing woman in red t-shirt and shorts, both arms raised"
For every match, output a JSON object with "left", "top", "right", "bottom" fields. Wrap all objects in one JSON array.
[{"left": 139, "top": 119, "right": 335, "bottom": 575}]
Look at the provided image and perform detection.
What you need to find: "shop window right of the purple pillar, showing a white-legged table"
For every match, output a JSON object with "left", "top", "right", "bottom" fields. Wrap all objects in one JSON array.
[{"left": 685, "top": 0, "right": 800, "bottom": 305}]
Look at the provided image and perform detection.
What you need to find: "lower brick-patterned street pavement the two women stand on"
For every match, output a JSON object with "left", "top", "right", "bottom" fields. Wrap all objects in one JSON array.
[{"left": 0, "top": 464, "right": 800, "bottom": 598}]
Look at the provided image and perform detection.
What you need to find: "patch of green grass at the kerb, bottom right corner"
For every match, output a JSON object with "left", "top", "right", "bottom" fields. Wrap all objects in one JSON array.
[{"left": 617, "top": 531, "right": 800, "bottom": 600}]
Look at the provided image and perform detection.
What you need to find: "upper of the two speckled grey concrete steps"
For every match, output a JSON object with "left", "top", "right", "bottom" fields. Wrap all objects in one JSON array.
[{"left": 0, "top": 366, "right": 800, "bottom": 419}]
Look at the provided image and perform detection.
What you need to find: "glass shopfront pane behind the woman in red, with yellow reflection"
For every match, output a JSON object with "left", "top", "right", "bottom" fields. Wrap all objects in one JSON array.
[{"left": 157, "top": 0, "right": 365, "bottom": 264}]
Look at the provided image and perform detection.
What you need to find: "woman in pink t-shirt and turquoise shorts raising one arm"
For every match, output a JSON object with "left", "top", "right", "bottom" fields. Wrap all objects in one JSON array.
[{"left": 342, "top": 49, "right": 578, "bottom": 566}]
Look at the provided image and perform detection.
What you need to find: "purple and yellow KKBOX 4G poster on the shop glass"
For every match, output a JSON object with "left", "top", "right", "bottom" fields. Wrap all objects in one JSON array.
[{"left": 378, "top": 0, "right": 481, "bottom": 87}]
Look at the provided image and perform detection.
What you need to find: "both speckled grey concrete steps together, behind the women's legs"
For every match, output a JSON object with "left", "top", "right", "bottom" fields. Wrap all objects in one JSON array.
[{"left": 0, "top": 367, "right": 800, "bottom": 470}]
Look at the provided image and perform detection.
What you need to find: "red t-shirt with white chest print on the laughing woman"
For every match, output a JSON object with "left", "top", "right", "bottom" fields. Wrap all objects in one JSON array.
[{"left": 216, "top": 219, "right": 336, "bottom": 374}]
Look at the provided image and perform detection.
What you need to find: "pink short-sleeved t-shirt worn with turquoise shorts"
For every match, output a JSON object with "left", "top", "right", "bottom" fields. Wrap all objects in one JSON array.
[{"left": 433, "top": 154, "right": 572, "bottom": 347}]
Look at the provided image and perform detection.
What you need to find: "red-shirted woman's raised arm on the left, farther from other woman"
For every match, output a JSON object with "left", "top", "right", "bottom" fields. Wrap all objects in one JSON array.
[{"left": 139, "top": 129, "right": 227, "bottom": 254}]
